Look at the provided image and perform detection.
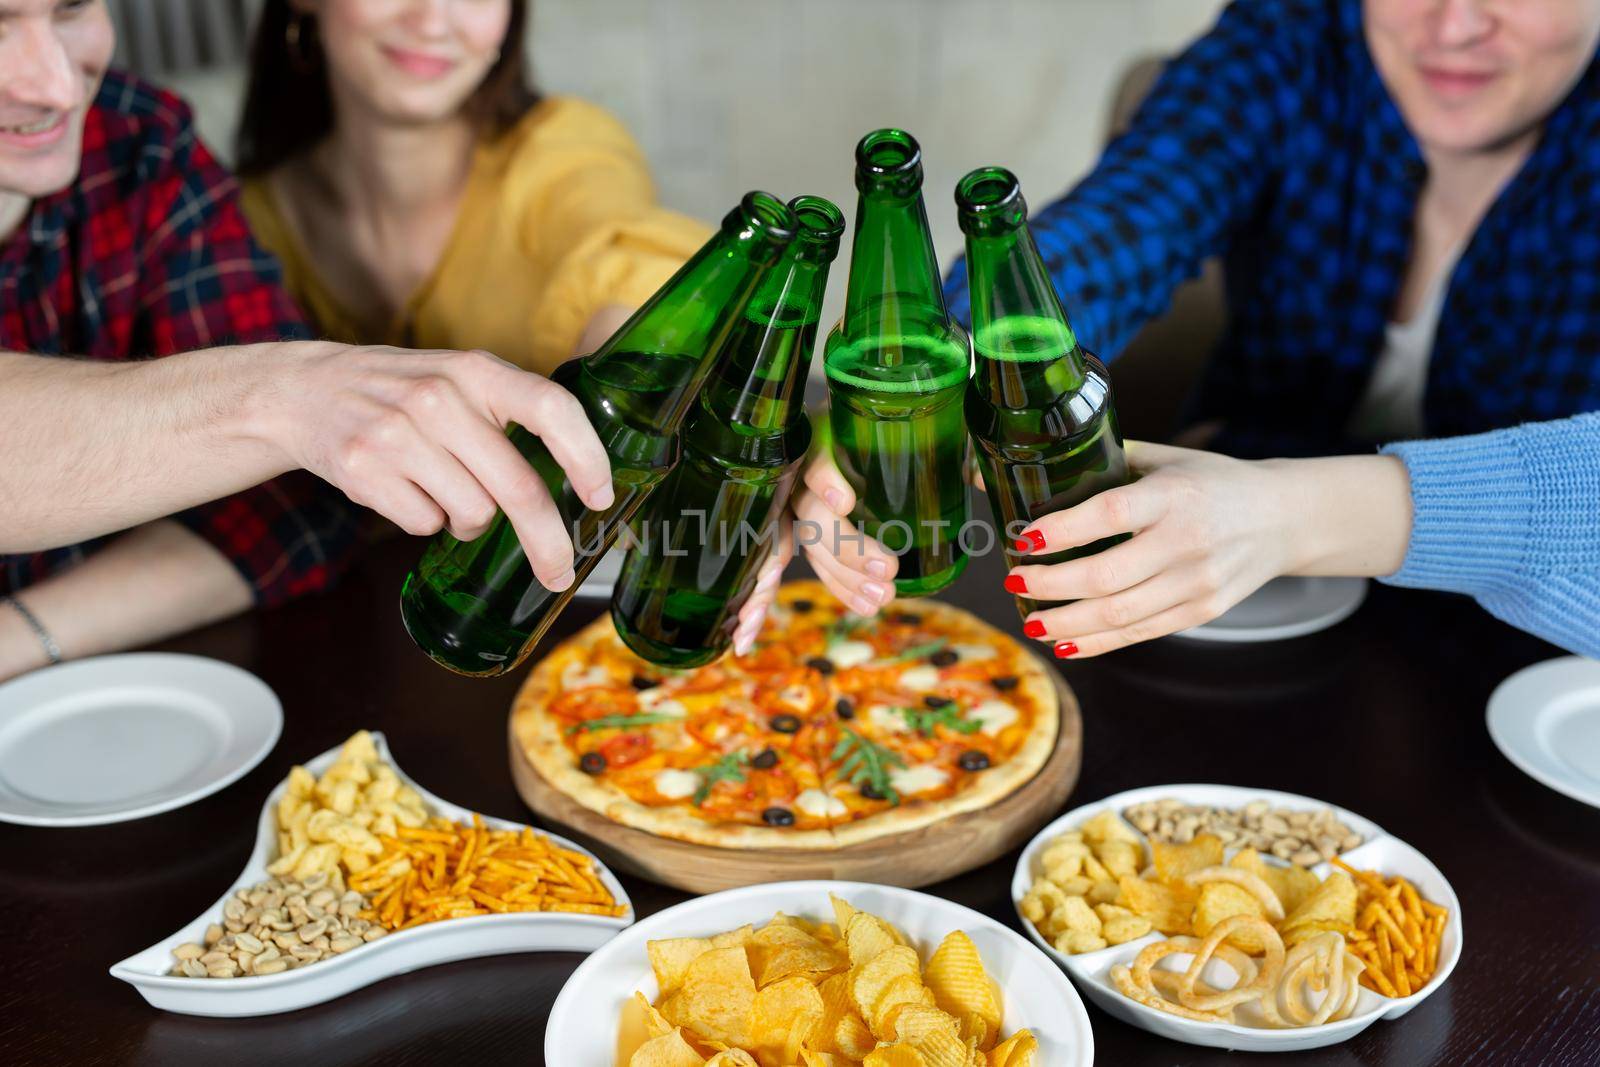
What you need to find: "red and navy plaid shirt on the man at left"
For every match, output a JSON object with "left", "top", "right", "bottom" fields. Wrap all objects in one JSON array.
[{"left": 0, "top": 72, "right": 357, "bottom": 603}]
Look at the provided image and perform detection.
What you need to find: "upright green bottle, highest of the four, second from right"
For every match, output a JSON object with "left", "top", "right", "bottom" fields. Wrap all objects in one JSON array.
[{"left": 822, "top": 130, "right": 971, "bottom": 597}]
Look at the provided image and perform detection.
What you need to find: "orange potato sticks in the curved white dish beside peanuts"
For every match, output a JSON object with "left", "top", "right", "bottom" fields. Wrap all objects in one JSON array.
[{"left": 350, "top": 816, "right": 626, "bottom": 929}]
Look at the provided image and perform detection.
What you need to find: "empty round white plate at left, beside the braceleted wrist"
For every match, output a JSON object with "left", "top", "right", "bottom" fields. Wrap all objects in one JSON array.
[{"left": 0, "top": 653, "right": 283, "bottom": 825}]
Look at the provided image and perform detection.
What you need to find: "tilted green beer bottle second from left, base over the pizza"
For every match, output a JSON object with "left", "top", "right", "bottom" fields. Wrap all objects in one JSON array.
[{"left": 611, "top": 197, "right": 845, "bottom": 667}]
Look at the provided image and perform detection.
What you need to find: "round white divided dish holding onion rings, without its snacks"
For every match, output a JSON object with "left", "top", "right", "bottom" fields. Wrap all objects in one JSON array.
[{"left": 1011, "top": 785, "right": 1461, "bottom": 1053}]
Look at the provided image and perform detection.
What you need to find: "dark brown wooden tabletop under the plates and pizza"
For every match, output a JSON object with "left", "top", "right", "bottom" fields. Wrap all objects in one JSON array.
[{"left": 0, "top": 541, "right": 1600, "bottom": 1067}]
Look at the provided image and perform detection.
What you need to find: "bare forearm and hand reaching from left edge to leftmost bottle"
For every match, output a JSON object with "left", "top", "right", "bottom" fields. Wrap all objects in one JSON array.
[{"left": 0, "top": 342, "right": 611, "bottom": 582}]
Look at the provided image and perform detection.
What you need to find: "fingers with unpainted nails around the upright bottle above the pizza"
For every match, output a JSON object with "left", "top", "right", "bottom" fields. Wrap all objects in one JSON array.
[{"left": 792, "top": 442, "right": 899, "bottom": 616}]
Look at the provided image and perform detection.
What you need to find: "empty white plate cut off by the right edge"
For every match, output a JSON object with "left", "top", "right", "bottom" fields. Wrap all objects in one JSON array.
[{"left": 1488, "top": 656, "right": 1600, "bottom": 808}]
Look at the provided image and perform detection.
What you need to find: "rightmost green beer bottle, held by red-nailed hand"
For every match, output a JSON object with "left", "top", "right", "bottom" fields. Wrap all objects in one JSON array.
[{"left": 955, "top": 166, "right": 1128, "bottom": 617}]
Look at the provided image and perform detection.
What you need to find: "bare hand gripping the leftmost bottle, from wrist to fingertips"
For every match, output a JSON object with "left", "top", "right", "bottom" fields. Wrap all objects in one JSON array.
[{"left": 266, "top": 344, "right": 614, "bottom": 590}]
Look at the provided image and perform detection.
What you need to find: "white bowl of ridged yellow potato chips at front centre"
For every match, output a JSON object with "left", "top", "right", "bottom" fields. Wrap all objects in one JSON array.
[{"left": 544, "top": 881, "right": 1094, "bottom": 1067}]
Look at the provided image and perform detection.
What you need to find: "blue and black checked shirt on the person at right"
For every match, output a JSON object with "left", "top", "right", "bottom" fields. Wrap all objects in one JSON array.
[{"left": 947, "top": 0, "right": 1600, "bottom": 456}]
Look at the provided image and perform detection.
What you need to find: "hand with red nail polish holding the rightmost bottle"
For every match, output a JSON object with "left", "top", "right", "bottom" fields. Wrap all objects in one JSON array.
[{"left": 1006, "top": 442, "right": 1411, "bottom": 657}]
